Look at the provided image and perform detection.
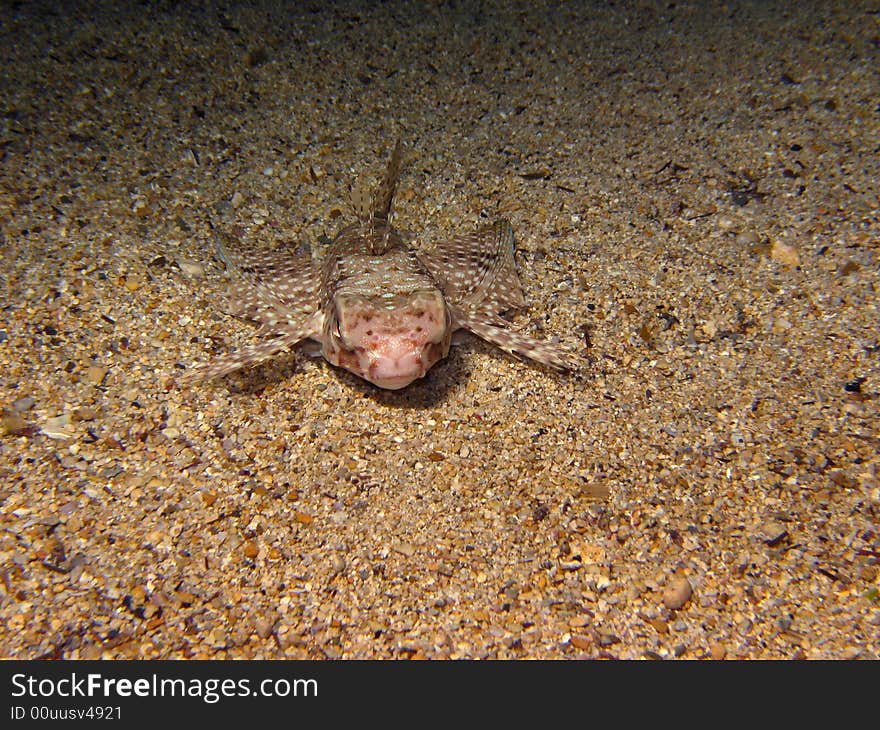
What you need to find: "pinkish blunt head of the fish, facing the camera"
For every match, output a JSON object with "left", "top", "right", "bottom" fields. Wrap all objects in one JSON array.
[{"left": 322, "top": 289, "right": 452, "bottom": 390}]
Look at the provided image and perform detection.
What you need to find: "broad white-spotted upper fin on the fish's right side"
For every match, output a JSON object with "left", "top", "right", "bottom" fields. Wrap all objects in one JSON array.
[{"left": 419, "top": 220, "right": 525, "bottom": 314}]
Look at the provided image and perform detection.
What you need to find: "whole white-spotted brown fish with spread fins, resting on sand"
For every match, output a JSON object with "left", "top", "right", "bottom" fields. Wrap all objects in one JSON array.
[{"left": 184, "top": 140, "right": 586, "bottom": 390}]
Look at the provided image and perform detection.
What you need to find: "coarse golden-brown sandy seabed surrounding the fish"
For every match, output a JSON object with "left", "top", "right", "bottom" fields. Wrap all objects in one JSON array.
[{"left": 0, "top": 1, "right": 880, "bottom": 659}]
